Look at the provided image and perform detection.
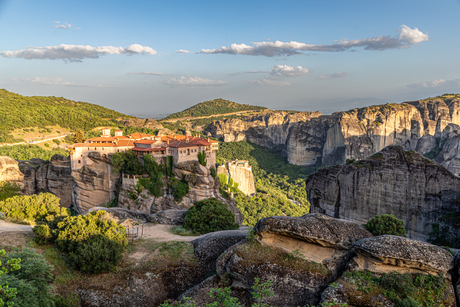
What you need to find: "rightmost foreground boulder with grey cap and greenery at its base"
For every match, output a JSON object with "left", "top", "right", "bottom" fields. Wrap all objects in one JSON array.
[{"left": 321, "top": 236, "right": 456, "bottom": 307}]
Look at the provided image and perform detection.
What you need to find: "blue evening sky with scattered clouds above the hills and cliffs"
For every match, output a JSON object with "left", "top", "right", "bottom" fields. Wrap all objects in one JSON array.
[{"left": 0, "top": 0, "right": 460, "bottom": 116}]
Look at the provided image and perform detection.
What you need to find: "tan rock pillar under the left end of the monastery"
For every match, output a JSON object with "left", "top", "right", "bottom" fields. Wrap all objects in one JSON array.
[{"left": 72, "top": 152, "right": 120, "bottom": 213}]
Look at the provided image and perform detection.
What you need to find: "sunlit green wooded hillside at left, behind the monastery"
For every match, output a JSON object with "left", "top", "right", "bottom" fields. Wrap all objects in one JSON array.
[{"left": 0, "top": 89, "right": 132, "bottom": 142}]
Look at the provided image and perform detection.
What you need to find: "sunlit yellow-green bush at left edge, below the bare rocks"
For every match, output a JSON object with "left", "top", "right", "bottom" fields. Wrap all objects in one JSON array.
[{"left": 0, "top": 193, "right": 69, "bottom": 224}]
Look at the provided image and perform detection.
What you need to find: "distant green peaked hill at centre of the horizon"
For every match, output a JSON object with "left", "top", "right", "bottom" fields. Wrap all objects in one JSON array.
[{"left": 164, "top": 98, "right": 267, "bottom": 119}]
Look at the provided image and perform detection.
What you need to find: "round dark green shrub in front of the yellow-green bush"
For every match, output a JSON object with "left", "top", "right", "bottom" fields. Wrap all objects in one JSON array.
[{"left": 69, "top": 235, "right": 124, "bottom": 274}]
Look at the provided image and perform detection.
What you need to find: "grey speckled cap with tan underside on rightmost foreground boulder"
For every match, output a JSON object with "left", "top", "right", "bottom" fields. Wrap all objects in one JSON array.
[{"left": 353, "top": 235, "right": 454, "bottom": 276}]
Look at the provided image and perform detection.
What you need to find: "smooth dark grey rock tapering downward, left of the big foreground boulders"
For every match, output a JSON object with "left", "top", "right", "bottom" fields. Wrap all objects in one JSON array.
[{"left": 192, "top": 230, "right": 247, "bottom": 274}]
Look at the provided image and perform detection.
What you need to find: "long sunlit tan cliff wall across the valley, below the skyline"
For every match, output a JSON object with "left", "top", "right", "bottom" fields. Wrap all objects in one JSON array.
[{"left": 206, "top": 96, "right": 460, "bottom": 166}]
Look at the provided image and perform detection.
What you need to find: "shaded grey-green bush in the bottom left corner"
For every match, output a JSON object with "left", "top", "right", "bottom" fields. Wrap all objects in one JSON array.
[{"left": 0, "top": 248, "right": 54, "bottom": 307}]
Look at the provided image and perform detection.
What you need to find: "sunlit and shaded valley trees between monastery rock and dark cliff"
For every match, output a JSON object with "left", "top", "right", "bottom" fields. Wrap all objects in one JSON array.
[{"left": 217, "top": 141, "right": 314, "bottom": 226}]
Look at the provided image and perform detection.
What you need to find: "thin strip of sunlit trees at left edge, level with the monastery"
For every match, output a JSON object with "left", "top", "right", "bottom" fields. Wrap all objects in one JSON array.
[{"left": 0, "top": 145, "right": 69, "bottom": 161}]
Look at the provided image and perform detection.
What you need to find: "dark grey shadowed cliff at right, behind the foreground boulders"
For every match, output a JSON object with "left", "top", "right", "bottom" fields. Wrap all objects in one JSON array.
[{"left": 306, "top": 146, "right": 460, "bottom": 239}]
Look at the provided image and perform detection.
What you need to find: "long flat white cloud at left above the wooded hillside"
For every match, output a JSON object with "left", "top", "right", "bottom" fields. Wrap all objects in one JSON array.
[{"left": 0, "top": 44, "right": 157, "bottom": 62}]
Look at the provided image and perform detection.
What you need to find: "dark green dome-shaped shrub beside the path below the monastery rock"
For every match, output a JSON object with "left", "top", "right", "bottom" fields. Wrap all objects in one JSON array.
[{"left": 184, "top": 197, "right": 238, "bottom": 233}]
